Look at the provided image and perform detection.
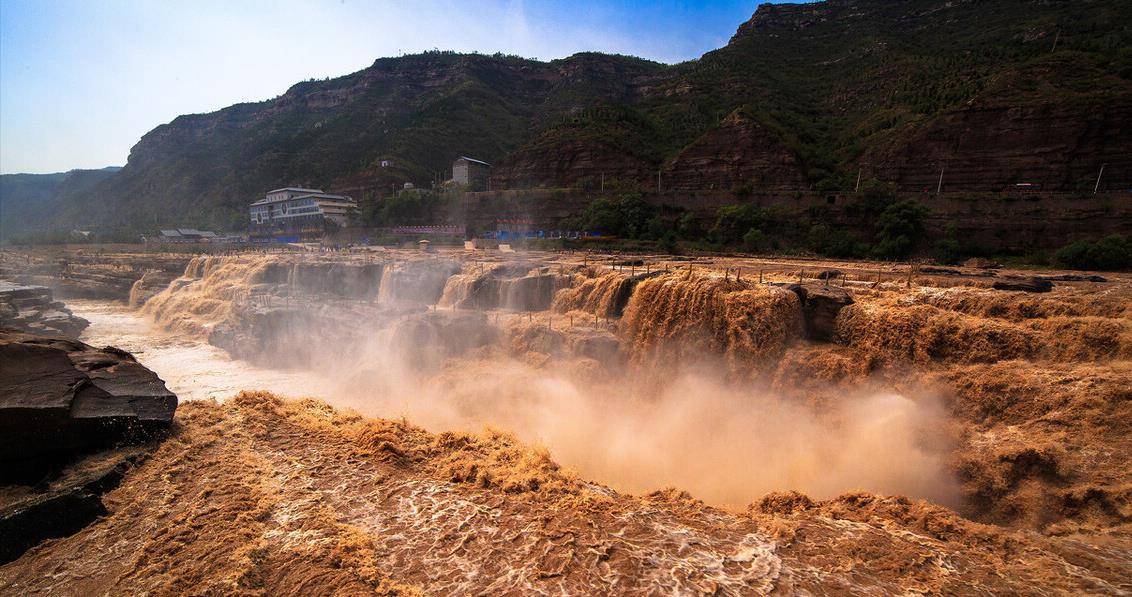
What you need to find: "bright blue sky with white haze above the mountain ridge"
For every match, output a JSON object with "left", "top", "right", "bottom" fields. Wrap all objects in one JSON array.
[{"left": 0, "top": 0, "right": 787, "bottom": 173}]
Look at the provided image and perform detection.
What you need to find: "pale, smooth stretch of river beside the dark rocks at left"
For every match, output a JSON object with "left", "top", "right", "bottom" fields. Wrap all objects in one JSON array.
[{"left": 67, "top": 299, "right": 332, "bottom": 400}]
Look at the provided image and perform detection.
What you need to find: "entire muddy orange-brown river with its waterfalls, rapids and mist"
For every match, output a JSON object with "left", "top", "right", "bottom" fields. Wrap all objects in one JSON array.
[{"left": 0, "top": 254, "right": 1132, "bottom": 595}]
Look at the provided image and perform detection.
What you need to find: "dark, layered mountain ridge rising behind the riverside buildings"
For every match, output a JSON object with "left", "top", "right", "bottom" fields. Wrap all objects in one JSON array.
[{"left": 2, "top": 0, "right": 1132, "bottom": 235}]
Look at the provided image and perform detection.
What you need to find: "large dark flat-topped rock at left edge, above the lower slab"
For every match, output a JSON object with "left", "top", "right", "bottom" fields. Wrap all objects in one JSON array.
[{"left": 0, "top": 329, "right": 177, "bottom": 481}]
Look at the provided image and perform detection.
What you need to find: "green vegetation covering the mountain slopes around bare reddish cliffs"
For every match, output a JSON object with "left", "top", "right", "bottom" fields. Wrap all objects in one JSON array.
[{"left": 5, "top": 0, "right": 1132, "bottom": 259}]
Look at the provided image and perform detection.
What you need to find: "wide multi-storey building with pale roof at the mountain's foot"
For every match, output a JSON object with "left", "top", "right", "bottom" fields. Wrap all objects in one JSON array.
[{"left": 249, "top": 187, "right": 358, "bottom": 237}]
